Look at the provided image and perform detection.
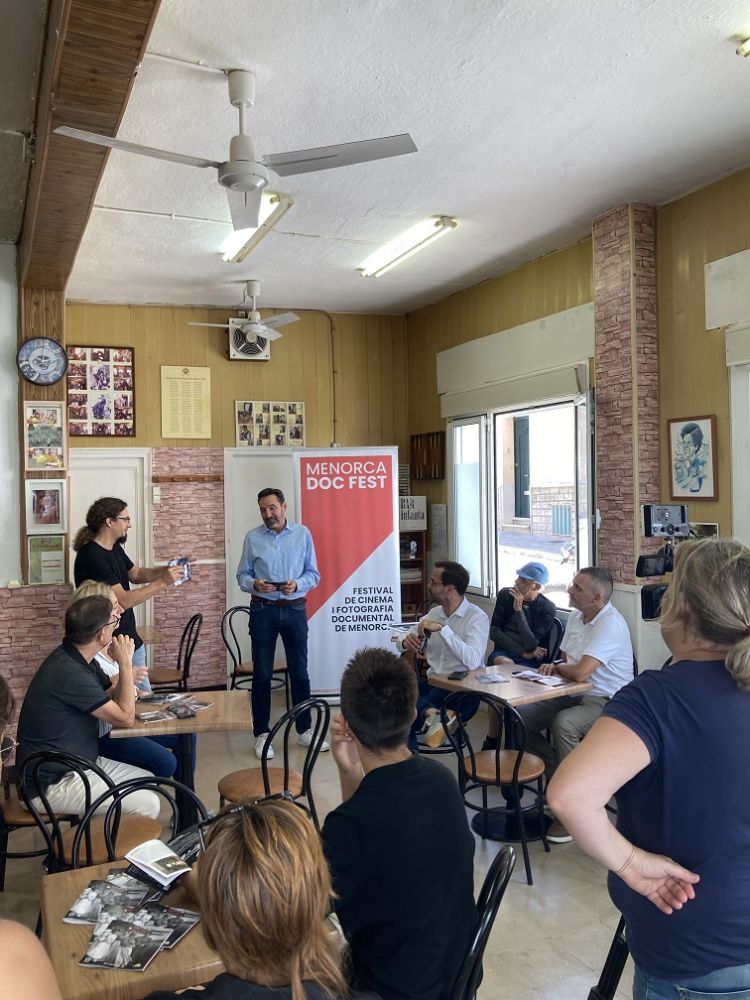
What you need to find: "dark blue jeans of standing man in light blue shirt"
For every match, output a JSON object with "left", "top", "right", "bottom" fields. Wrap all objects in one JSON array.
[{"left": 250, "top": 601, "right": 310, "bottom": 736}]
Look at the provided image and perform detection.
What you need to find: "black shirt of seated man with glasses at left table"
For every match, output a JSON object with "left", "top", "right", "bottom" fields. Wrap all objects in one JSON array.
[{"left": 17, "top": 639, "right": 112, "bottom": 791}]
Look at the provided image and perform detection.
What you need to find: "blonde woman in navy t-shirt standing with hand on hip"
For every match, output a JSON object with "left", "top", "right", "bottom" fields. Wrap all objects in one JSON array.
[{"left": 547, "top": 539, "right": 750, "bottom": 1000}]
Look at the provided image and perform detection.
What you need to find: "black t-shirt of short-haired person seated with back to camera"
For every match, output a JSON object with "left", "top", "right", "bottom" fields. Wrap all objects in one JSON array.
[{"left": 323, "top": 755, "right": 478, "bottom": 1000}]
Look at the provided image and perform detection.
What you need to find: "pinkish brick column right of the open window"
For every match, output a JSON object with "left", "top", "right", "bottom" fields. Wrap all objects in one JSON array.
[{"left": 593, "top": 204, "right": 660, "bottom": 585}]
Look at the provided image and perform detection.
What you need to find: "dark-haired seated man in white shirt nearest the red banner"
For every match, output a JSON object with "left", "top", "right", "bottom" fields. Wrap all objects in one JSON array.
[{"left": 401, "top": 561, "right": 490, "bottom": 750}]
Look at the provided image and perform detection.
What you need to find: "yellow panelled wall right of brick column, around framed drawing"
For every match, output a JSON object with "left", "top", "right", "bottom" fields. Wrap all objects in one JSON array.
[{"left": 656, "top": 170, "right": 750, "bottom": 534}]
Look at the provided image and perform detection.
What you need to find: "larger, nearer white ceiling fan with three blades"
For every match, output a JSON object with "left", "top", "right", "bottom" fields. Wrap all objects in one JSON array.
[{"left": 54, "top": 69, "right": 417, "bottom": 229}]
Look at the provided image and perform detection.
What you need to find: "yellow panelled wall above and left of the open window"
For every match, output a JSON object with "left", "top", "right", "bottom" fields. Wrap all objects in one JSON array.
[{"left": 407, "top": 239, "right": 594, "bottom": 503}]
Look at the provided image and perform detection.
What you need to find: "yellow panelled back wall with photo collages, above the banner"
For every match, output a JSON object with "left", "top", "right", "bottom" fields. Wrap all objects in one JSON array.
[{"left": 66, "top": 303, "right": 408, "bottom": 452}]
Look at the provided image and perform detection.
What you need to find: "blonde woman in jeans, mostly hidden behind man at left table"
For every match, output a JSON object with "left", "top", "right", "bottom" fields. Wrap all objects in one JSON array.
[{"left": 70, "top": 580, "right": 196, "bottom": 778}]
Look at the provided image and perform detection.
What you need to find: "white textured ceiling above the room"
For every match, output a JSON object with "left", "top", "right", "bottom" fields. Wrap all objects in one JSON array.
[{"left": 68, "top": 0, "right": 750, "bottom": 313}]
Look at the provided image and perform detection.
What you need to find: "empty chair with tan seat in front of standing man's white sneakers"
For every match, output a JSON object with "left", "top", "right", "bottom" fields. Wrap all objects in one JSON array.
[{"left": 219, "top": 698, "right": 331, "bottom": 829}]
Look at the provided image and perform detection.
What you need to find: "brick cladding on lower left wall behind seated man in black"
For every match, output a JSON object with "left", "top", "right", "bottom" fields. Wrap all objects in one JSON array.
[{"left": 0, "top": 586, "right": 72, "bottom": 736}]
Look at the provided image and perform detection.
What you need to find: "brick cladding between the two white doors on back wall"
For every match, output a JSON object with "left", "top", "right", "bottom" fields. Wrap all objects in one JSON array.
[{"left": 152, "top": 448, "right": 226, "bottom": 688}]
